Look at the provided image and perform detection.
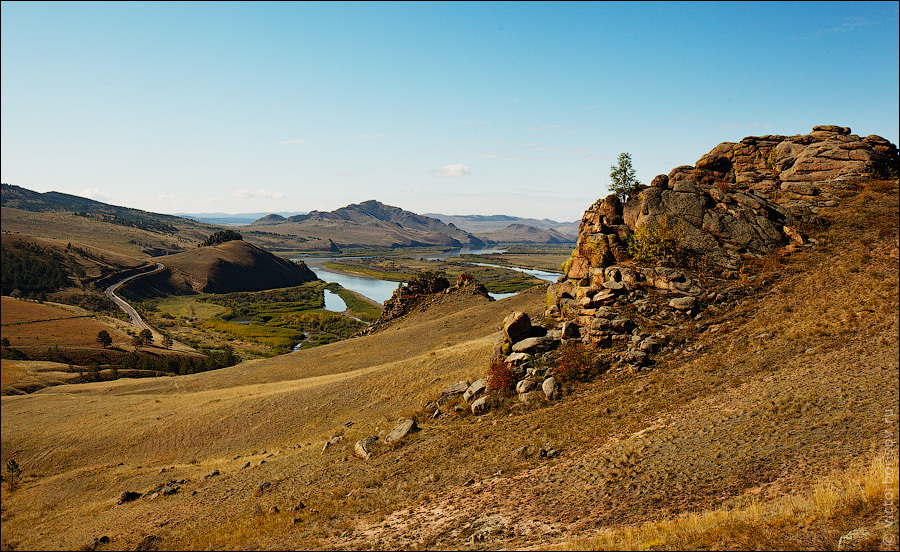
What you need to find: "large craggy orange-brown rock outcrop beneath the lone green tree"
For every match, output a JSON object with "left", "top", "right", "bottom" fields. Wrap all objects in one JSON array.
[{"left": 546, "top": 125, "right": 900, "bottom": 352}]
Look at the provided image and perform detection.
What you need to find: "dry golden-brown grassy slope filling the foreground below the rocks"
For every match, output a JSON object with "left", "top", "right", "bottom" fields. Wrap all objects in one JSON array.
[{"left": 2, "top": 182, "right": 900, "bottom": 549}]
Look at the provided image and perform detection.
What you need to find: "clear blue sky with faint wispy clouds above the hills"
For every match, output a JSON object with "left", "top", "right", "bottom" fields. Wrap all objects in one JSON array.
[{"left": 0, "top": 2, "right": 900, "bottom": 221}]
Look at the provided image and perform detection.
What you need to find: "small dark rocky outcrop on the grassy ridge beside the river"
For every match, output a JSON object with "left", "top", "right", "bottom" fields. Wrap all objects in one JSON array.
[{"left": 356, "top": 272, "right": 493, "bottom": 336}]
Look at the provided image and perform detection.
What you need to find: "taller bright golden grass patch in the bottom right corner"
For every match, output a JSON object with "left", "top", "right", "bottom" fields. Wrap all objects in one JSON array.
[{"left": 561, "top": 455, "right": 900, "bottom": 550}]
